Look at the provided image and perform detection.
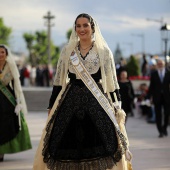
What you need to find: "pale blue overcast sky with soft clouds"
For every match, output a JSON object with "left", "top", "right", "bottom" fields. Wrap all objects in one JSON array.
[{"left": 0, "top": 0, "right": 170, "bottom": 56}]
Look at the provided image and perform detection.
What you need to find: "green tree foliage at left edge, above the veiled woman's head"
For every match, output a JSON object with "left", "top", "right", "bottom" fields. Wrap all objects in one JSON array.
[{"left": 0, "top": 18, "right": 12, "bottom": 45}]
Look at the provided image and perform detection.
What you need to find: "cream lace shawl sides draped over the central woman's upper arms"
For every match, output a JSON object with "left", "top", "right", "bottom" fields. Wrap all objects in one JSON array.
[{"left": 53, "top": 43, "right": 119, "bottom": 93}]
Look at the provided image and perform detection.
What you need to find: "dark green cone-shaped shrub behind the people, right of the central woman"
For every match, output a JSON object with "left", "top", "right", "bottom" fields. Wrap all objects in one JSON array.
[{"left": 126, "top": 55, "right": 140, "bottom": 76}]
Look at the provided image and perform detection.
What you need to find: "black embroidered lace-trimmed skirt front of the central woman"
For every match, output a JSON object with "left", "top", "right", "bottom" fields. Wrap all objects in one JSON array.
[{"left": 43, "top": 83, "right": 121, "bottom": 170}]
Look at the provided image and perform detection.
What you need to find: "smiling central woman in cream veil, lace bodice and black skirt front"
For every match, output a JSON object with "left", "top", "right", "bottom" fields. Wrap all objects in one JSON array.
[{"left": 33, "top": 14, "right": 130, "bottom": 170}]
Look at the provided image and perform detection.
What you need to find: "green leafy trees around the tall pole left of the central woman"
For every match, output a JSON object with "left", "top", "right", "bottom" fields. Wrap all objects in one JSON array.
[{"left": 23, "top": 31, "right": 59, "bottom": 65}]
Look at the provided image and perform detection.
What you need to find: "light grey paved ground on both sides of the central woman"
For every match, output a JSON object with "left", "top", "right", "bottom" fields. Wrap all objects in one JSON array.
[{"left": 0, "top": 112, "right": 170, "bottom": 170}]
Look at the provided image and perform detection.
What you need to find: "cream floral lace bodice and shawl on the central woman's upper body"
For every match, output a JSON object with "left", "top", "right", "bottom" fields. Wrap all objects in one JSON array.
[{"left": 54, "top": 42, "right": 119, "bottom": 92}]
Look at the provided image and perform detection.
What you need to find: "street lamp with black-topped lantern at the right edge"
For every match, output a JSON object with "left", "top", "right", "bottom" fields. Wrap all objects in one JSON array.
[{"left": 160, "top": 24, "right": 170, "bottom": 64}]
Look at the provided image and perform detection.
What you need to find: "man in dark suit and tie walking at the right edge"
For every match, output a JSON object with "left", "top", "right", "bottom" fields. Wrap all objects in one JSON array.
[{"left": 148, "top": 59, "right": 170, "bottom": 138}]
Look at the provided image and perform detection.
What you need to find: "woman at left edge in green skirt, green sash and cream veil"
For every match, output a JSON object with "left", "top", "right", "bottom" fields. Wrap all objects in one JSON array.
[{"left": 0, "top": 45, "right": 32, "bottom": 161}]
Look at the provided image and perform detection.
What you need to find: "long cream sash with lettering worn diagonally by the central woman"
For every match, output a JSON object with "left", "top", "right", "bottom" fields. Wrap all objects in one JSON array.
[{"left": 70, "top": 52, "right": 131, "bottom": 165}]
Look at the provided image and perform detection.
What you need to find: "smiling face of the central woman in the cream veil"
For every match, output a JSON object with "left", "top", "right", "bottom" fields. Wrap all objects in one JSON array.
[{"left": 76, "top": 17, "right": 93, "bottom": 40}]
